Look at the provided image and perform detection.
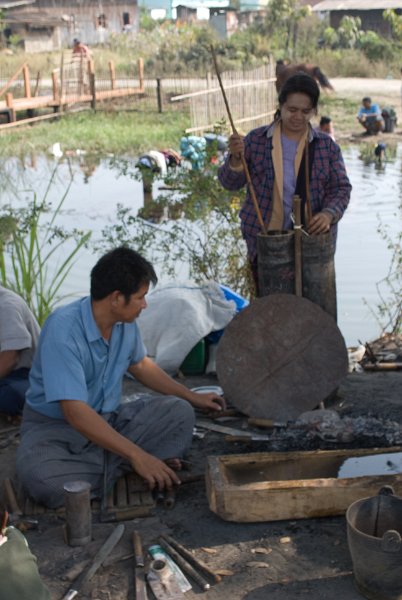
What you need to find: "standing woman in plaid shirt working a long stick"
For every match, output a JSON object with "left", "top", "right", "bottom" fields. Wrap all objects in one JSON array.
[{"left": 218, "top": 72, "right": 352, "bottom": 290}]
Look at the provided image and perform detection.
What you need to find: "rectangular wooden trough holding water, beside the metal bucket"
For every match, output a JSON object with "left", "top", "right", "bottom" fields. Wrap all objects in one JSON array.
[{"left": 206, "top": 447, "right": 402, "bottom": 522}]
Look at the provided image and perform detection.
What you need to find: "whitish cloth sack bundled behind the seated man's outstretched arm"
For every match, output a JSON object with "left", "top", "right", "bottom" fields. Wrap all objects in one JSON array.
[{"left": 137, "top": 281, "right": 236, "bottom": 374}]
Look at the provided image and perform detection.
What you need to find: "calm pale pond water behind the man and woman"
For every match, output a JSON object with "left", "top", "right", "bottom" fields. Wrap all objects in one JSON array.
[{"left": 0, "top": 145, "right": 402, "bottom": 346}]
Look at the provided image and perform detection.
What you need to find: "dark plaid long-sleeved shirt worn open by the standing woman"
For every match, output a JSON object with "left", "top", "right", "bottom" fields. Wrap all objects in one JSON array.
[{"left": 218, "top": 124, "right": 352, "bottom": 260}]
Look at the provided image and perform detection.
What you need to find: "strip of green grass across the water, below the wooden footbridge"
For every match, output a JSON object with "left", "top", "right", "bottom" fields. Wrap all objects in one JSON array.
[{"left": 0, "top": 110, "right": 189, "bottom": 156}]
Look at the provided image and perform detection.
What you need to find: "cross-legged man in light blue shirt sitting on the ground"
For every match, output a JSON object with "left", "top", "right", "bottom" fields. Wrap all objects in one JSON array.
[{"left": 17, "top": 247, "right": 225, "bottom": 508}]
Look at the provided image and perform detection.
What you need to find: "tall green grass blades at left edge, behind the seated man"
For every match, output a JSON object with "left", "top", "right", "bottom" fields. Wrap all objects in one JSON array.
[{"left": 0, "top": 169, "right": 91, "bottom": 325}]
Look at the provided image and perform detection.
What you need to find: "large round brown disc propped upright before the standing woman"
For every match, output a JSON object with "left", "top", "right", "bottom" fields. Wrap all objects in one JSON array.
[{"left": 216, "top": 294, "right": 348, "bottom": 421}]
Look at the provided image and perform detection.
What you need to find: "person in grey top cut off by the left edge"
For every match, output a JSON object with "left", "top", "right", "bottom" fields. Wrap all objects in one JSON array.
[{"left": 0, "top": 285, "right": 40, "bottom": 416}]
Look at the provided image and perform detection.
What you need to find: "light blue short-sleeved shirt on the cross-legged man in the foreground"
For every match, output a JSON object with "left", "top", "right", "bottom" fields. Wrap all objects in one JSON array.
[{"left": 26, "top": 297, "right": 146, "bottom": 419}]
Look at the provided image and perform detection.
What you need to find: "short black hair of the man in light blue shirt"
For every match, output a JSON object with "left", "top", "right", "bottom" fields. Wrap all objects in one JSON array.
[{"left": 91, "top": 246, "right": 158, "bottom": 302}]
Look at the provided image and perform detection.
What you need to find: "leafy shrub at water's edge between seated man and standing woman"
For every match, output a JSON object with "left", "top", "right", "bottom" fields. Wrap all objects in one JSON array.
[{"left": 99, "top": 145, "right": 251, "bottom": 296}]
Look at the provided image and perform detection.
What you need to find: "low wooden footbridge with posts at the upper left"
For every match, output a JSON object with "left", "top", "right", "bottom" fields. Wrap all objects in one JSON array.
[{"left": 0, "top": 58, "right": 144, "bottom": 129}]
